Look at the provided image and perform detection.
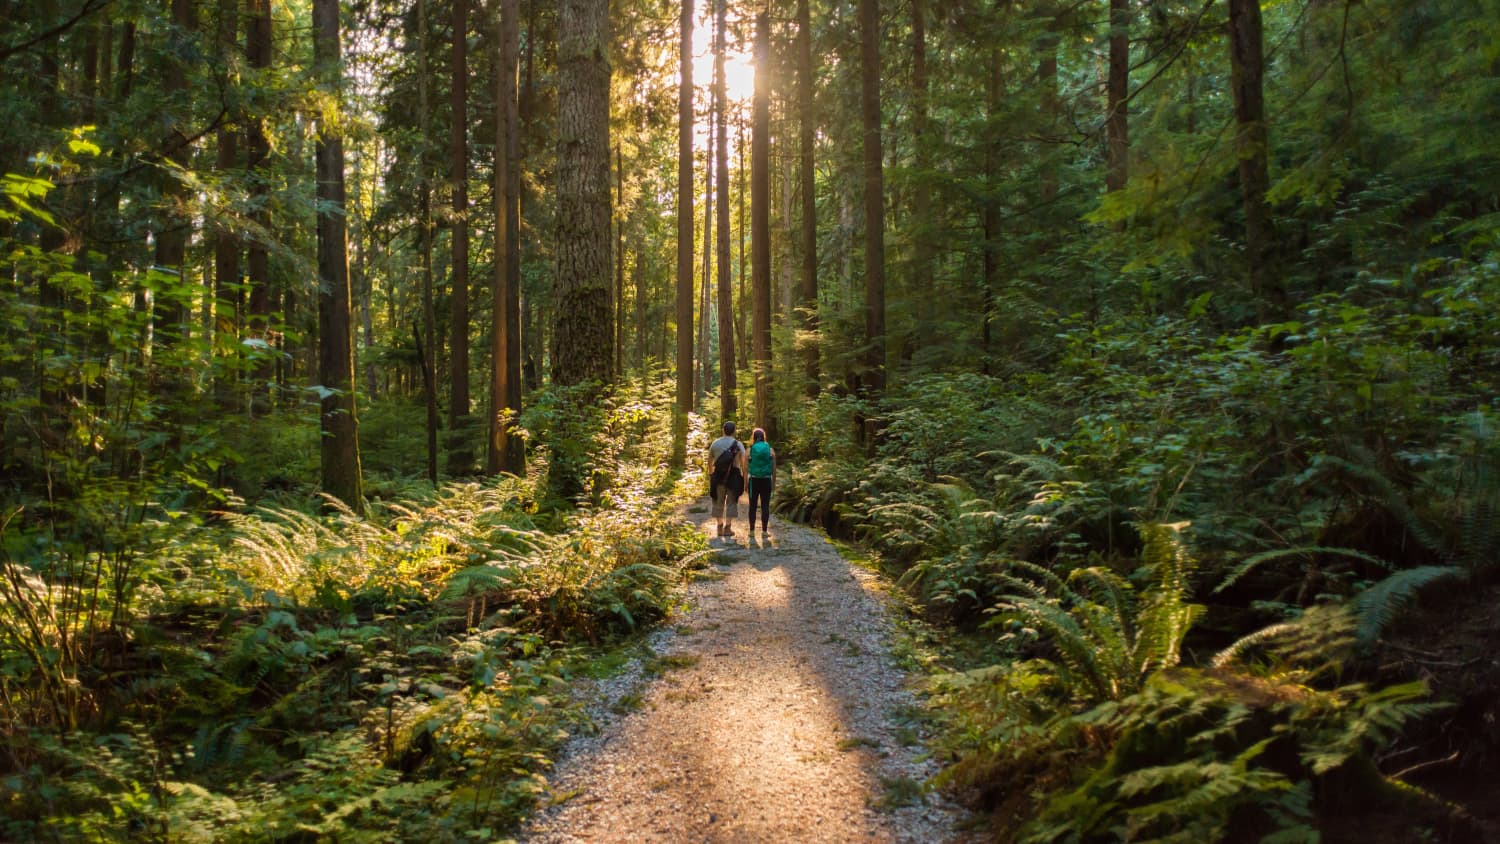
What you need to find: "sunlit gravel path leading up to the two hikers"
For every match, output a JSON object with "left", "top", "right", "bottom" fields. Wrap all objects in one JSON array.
[{"left": 522, "top": 507, "right": 959, "bottom": 843}]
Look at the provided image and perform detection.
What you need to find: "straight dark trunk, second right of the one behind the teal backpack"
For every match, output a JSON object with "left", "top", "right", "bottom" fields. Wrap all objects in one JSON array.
[{"left": 860, "top": 0, "right": 885, "bottom": 396}]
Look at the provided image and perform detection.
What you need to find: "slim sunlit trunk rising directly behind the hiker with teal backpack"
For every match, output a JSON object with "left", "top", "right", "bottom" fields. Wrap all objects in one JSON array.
[{"left": 750, "top": 12, "right": 774, "bottom": 439}]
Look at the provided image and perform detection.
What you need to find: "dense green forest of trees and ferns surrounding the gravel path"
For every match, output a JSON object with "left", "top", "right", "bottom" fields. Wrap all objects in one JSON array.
[{"left": 0, "top": 0, "right": 1500, "bottom": 840}]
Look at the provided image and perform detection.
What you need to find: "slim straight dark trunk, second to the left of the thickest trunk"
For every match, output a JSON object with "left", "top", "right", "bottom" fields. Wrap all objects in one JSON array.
[{"left": 449, "top": 0, "right": 474, "bottom": 475}]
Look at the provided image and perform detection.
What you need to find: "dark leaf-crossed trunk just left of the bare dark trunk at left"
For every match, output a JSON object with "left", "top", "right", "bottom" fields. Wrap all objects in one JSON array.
[{"left": 246, "top": 0, "right": 276, "bottom": 417}]
